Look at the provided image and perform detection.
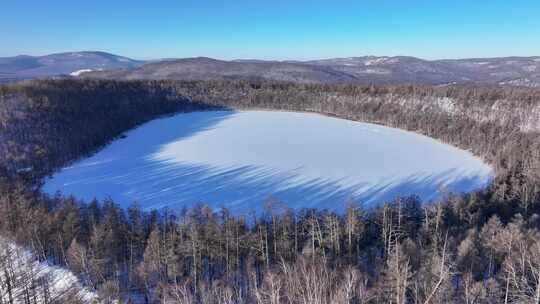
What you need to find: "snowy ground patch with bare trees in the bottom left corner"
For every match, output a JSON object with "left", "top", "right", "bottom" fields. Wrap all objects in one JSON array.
[{"left": 0, "top": 237, "right": 98, "bottom": 303}]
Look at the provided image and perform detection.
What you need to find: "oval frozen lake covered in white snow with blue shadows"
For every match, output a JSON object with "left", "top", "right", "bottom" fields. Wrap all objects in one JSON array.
[{"left": 44, "top": 111, "right": 493, "bottom": 214}]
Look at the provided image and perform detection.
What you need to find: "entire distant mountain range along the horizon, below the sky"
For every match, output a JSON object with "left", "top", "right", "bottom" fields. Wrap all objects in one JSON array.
[{"left": 0, "top": 52, "right": 540, "bottom": 87}]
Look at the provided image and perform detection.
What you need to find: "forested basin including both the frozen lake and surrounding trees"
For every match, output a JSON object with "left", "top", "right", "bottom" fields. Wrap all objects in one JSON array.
[{"left": 0, "top": 79, "right": 540, "bottom": 303}]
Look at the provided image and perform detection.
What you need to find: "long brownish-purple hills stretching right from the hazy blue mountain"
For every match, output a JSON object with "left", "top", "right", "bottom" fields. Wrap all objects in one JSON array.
[{"left": 84, "top": 56, "right": 540, "bottom": 87}]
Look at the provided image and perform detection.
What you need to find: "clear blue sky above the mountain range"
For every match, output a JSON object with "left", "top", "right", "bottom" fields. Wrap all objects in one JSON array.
[{"left": 0, "top": 0, "right": 540, "bottom": 59}]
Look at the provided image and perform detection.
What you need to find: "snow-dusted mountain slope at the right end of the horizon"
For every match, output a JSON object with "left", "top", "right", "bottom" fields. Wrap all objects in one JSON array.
[{"left": 309, "top": 56, "right": 540, "bottom": 86}]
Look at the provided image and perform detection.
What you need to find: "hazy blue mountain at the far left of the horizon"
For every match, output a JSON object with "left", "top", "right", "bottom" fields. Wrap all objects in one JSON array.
[{"left": 0, "top": 52, "right": 144, "bottom": 80}]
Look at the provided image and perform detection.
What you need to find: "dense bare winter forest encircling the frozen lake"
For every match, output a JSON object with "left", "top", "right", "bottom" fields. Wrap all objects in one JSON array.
[{"left": 0, "top": 80, "right": 540, "bottom": 304}]
